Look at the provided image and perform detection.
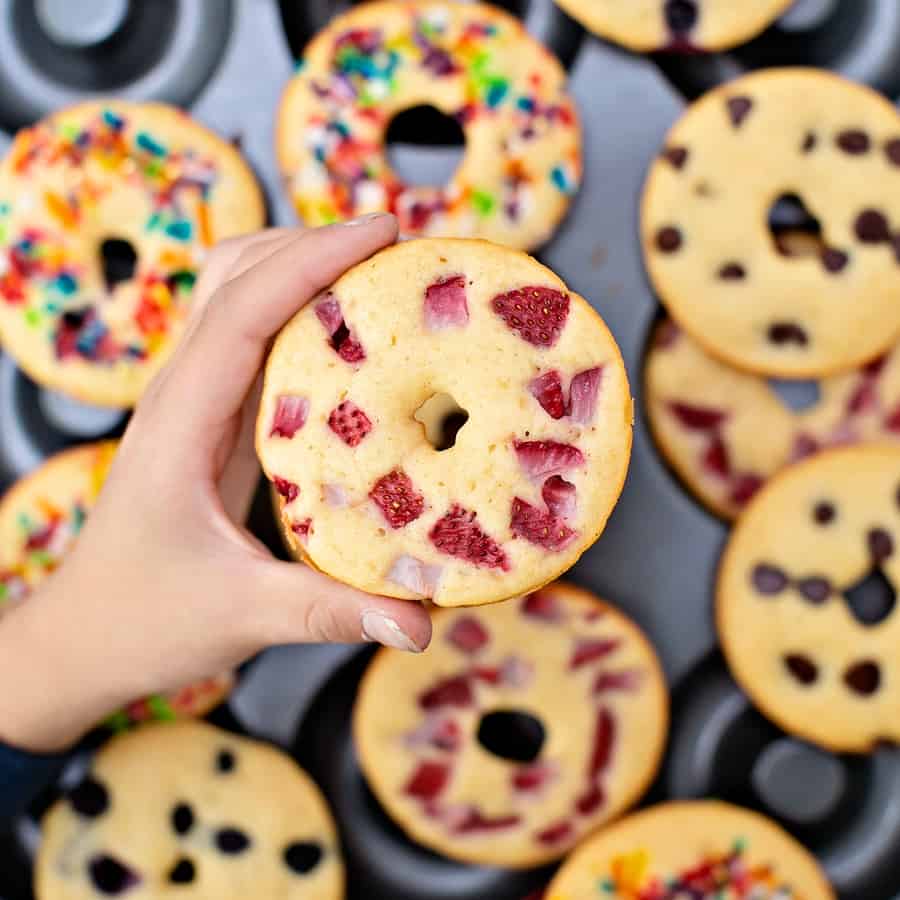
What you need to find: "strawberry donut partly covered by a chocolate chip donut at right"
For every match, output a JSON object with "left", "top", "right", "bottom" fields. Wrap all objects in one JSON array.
[{"left": 644, "top": 320, "right": 900, "bottom": 519}]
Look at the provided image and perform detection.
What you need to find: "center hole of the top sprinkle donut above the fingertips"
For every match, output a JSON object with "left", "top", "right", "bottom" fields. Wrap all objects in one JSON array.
[{"left": 385, "top": 104, "right": 466, "bottom": 187}]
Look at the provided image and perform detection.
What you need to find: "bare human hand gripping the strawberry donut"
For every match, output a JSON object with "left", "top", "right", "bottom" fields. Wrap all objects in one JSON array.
[{"left": 0, "top": 215, "right": 431, "bottom": 752}]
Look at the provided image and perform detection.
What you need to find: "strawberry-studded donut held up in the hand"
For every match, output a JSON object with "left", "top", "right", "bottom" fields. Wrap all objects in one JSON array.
[{"left": 256, "top": 239, "right": 632, "bottom": 606}]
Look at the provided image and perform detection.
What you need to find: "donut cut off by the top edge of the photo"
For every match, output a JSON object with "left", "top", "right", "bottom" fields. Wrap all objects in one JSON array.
[{"left": 557, "top": 0, "right": 793, "bottom": 52}]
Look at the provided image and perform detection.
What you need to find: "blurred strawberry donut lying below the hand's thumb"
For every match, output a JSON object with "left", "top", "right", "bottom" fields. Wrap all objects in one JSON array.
[{"left": 353, "top": 582, "right": 668, "bottom": 868}]
